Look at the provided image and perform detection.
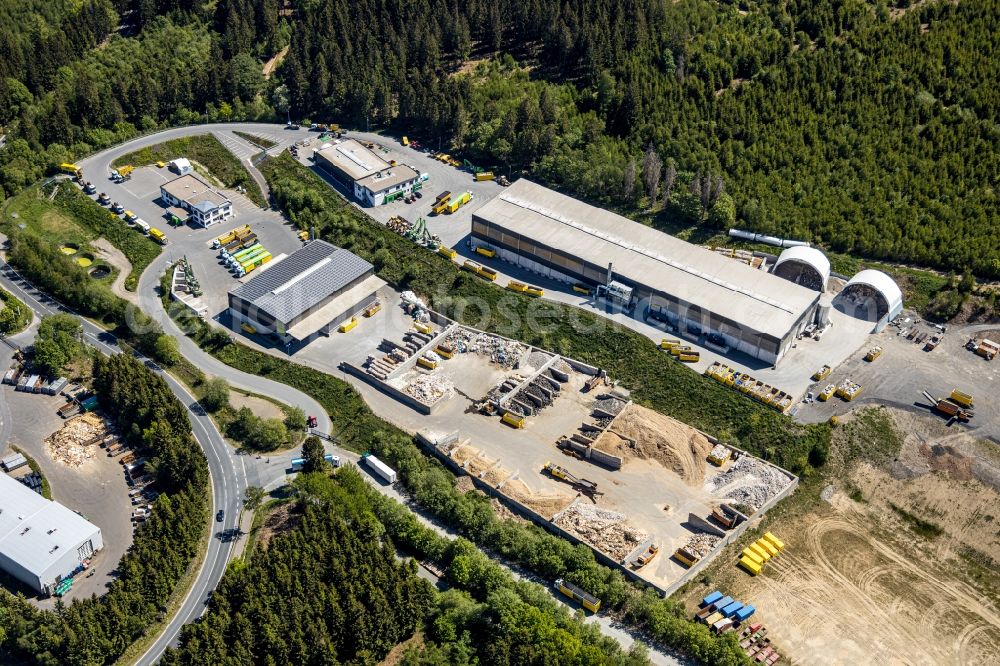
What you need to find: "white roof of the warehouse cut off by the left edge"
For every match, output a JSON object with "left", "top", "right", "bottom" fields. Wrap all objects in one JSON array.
[{"left": 0, "top": 474, "right": 100, "bottom": 576}]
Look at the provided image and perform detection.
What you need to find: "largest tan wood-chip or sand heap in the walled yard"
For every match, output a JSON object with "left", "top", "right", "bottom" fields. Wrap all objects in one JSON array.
[{"left": 594, "top": 404, "right": 712, "bottom": 485}]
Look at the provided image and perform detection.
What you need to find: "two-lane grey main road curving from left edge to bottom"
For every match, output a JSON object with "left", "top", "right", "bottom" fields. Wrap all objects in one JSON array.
[{"left": 0, "top": 262, "right": 247, "bottom": 665}]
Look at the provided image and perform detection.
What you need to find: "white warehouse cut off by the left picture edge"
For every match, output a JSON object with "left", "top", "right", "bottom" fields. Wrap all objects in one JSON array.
[{"left": 0, "top": 474, "right": 104, "bottom": 594}]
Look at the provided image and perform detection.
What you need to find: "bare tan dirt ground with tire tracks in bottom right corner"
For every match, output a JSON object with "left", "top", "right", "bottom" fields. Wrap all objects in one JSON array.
[{"left": 687, "top": 411, "right": 1000, "bottom": 666}]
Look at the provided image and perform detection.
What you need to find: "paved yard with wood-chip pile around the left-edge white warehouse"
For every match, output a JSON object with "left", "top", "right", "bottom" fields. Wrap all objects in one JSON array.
[{"left": 0, "top": 378, "right": 133, "bottom": 608}]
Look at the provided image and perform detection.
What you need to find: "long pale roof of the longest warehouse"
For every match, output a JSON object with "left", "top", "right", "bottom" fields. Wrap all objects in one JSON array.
[{"left": 475, "top": 178, "right": 819, "bottom": 339}]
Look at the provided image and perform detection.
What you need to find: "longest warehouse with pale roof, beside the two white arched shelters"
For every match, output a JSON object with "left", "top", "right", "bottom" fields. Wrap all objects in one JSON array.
[{"left": 472, "top": 178, "right": 820, "bottom": 363}]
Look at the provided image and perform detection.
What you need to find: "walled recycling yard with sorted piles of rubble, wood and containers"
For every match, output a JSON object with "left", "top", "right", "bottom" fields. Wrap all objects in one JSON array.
[{"left": 341, "top": 296, "right": 795, "bottom": 589}]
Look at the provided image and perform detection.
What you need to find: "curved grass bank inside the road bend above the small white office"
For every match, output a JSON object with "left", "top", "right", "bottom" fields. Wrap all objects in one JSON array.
[{"left": 112, "top": 134, "right": 267, "bottom": 208}]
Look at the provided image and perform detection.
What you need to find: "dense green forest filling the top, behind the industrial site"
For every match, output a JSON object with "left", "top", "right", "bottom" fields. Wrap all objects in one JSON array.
[{"left": 0, "top": 0, "right": 1000, "bottom": 277}]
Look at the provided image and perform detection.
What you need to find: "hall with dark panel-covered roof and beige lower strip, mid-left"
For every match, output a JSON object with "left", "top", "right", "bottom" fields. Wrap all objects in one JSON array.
[{"left": 229, "top": 240, "right": 385, "bottom": 344}]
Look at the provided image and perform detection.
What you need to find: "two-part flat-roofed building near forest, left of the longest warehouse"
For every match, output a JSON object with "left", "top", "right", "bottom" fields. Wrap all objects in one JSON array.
[{"left": 313, "top": 139, "right": 421, "bottom": 206}]
